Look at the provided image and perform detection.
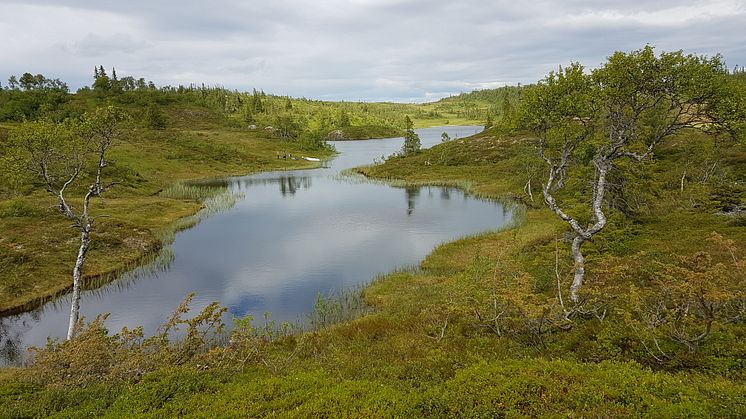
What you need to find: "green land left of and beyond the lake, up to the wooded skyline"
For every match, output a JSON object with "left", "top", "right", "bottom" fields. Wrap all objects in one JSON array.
[{"left": 0, "top": 67, "right": 512, "bottom": 313}]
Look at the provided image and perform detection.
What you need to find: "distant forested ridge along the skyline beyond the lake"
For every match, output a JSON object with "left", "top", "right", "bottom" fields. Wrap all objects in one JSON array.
[{"left": 0, "top": 66, "right": 522, "bottom": 142}]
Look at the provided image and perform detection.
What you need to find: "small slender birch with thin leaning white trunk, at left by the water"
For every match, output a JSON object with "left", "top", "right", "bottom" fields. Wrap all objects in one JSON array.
[{"left": 13, "top": 106, "right": 128, "bottom": 340}]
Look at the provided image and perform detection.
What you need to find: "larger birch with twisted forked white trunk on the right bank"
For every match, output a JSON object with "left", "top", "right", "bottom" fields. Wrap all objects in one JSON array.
[{"left": 521, "top": 46, "right": 727, "bottom": 302}]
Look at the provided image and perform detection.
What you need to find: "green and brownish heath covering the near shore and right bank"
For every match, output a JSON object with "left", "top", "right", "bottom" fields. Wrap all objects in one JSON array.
[{"left": 0, "top": 53, "right": 746, "bottom": 417}]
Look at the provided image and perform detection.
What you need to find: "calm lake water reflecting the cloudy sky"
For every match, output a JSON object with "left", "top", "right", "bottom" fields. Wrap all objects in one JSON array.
[{"left": 0, "top": 126, "right": 512, "bottom": 364}]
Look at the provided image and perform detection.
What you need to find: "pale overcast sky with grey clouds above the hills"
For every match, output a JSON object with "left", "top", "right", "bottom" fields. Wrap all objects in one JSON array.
[{"left": 0, "top": 0, "right": 746, "bottom": 102}]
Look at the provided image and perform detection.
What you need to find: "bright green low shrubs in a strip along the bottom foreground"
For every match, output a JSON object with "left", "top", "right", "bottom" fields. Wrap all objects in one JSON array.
[{"left": 0, "top": 359, "right": 746, "bottom": 417}]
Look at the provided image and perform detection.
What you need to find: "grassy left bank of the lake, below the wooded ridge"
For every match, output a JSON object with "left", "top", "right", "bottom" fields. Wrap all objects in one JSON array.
[{"left": 0, "top": 113, "right": 330, "bottom": 313}]
